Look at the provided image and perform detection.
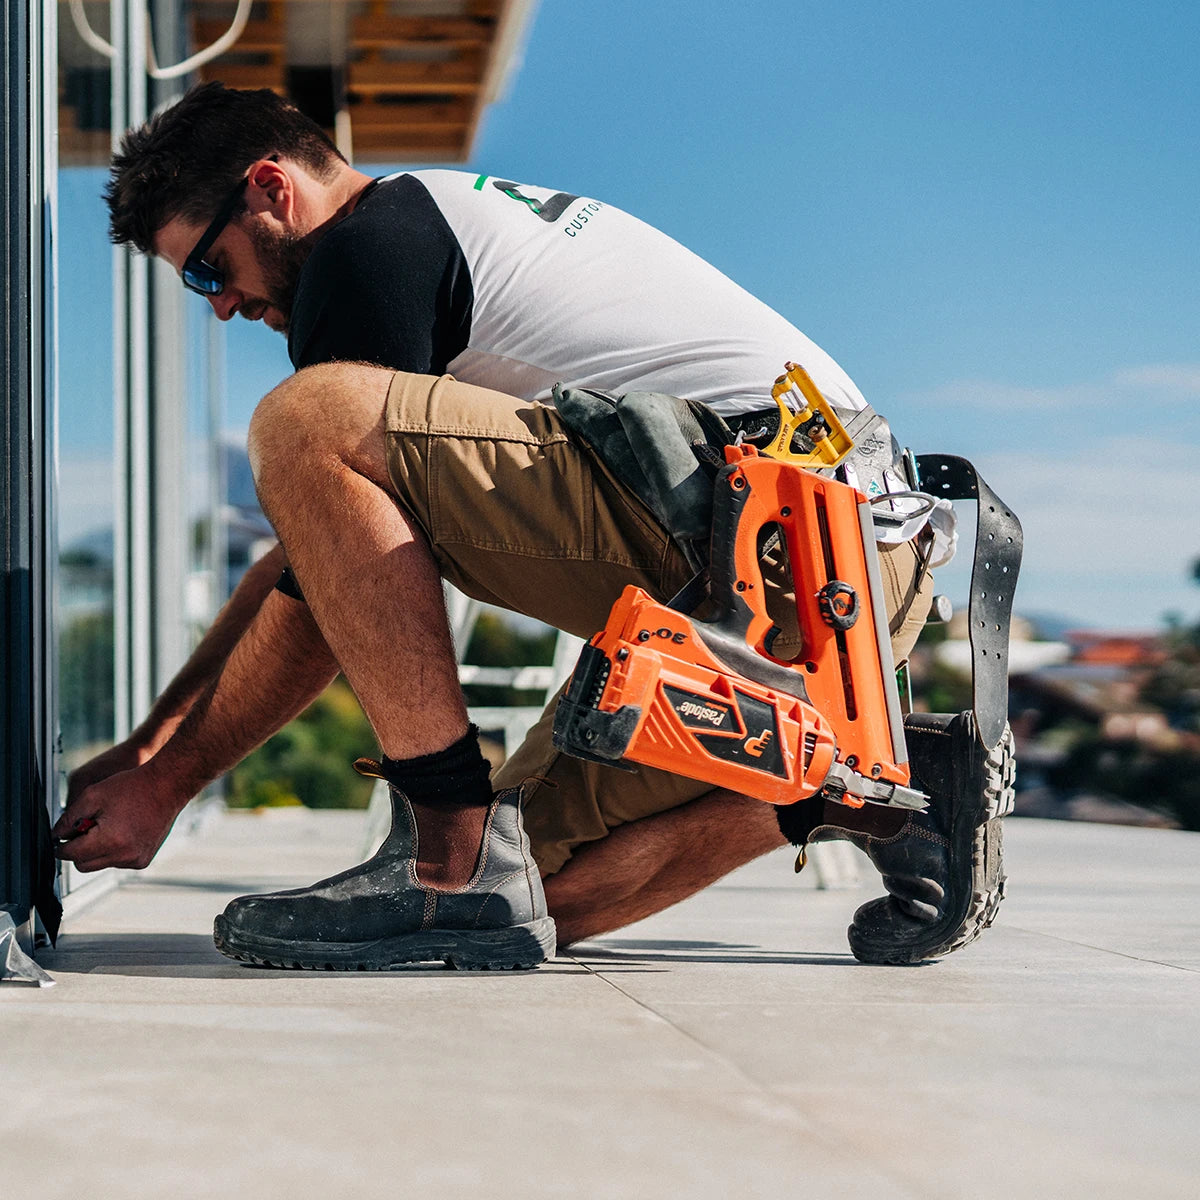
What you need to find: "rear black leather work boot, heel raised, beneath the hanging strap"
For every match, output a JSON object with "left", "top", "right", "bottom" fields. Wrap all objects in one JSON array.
[{"left": 778, "top": 712, "right": 1015, "bottom": 964}]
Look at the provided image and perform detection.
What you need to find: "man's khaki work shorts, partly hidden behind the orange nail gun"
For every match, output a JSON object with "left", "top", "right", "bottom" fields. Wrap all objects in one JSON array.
[{"left": 385, "top": 373, "right": 932, "bottom": 875}]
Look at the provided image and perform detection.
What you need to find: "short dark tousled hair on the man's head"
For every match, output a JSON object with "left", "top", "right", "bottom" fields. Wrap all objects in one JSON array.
[{"left": 104, "top": 83, "right": 346, "bottom": 254}]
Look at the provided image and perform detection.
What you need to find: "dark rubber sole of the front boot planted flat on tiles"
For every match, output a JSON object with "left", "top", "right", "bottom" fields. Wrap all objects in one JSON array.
[{"left": 212, "top": 917, "right": 556, "bottom": 971}]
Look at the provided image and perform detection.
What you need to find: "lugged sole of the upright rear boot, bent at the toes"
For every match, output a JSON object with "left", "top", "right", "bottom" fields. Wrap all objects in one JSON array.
[{"left": 847, "top": 725, "right": 1016, "bottom": 966}]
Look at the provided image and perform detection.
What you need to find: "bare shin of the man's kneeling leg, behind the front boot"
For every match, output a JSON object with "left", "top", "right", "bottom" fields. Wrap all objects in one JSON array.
[{"left": 545, "top": 791, "right": 786, "bottom": 946}]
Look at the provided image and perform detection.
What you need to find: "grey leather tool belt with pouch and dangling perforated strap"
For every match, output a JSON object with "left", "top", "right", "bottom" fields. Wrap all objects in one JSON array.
[{"left": 553, "top": 384, "right": 1022, "bottom": 749}]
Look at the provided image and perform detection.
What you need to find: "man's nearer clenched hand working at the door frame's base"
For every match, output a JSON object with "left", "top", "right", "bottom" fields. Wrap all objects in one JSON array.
[{"left": 53, "top": 748, "right": 188, "bottom": 871}]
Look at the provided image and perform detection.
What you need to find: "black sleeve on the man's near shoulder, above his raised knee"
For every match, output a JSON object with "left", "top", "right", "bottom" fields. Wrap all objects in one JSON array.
[{"left": 288, "top": 175, "right": 474, "bottom": 374}]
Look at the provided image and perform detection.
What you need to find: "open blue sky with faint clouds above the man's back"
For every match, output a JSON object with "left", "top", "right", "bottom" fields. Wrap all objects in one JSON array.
[{"left": 56, "top": 0, "right": 1200, "bottom": 628}]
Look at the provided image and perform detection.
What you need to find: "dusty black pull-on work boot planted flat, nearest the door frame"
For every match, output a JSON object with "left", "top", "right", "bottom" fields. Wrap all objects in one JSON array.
[{"left": 212, "top": 787, "right": 554, "bottom": 971}]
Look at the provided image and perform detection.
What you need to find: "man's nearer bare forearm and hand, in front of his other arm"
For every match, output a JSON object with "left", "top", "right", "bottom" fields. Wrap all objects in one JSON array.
[{"left": 54, "top": 589, "right": 337, "bottom": 871}]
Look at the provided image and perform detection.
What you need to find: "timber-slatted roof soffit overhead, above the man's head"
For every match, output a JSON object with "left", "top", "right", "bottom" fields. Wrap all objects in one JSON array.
[{"left": 59, "top": 0, "right": 535, "bottom": 164}]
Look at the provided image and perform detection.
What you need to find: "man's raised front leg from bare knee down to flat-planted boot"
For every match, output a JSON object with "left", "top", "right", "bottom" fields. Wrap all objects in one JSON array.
[{"left": 202, "top": 365, "right": 554, "bottom": 971}]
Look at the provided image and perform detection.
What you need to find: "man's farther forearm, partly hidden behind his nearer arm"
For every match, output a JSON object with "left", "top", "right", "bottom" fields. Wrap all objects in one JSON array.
[{"left": 67, "top": 545, "right": 286, "bottom": 806}]
